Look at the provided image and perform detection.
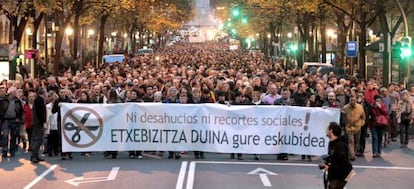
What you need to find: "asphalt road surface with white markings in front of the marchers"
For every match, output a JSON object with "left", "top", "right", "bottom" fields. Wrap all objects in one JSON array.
[{"left": 0, "top": 137, "right": 414, "bottom": 189}]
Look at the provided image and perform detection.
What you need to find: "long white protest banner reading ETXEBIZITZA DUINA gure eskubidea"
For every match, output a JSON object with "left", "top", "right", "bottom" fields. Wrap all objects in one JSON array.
[{"left": 61, "top": 103, "right": 340, "bottom": 155}]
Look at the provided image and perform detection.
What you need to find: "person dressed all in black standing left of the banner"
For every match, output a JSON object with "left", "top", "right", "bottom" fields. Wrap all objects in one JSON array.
[{"left": 30, "top": 88, "right": 47, "bottom": 163}]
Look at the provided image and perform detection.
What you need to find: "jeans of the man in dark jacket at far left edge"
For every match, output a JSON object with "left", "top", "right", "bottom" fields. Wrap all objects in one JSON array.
[{"left": 1, "top": 120, "right": 20, "bottom": 156}]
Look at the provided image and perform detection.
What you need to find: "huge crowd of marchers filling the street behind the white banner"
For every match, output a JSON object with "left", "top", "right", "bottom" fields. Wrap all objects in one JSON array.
[{"left": 0, "top": 42, "right": 414, "bottom": 162}]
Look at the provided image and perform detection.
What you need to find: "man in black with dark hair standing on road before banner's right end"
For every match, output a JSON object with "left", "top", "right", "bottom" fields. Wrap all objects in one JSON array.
[{"left": 322, "top": 122, "right": 352, "bottom": 189}]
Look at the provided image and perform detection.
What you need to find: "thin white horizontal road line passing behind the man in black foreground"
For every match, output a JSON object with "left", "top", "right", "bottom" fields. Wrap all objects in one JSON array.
[{"left": 191, "top": 161, "right": 414, "bottom": 171}]
